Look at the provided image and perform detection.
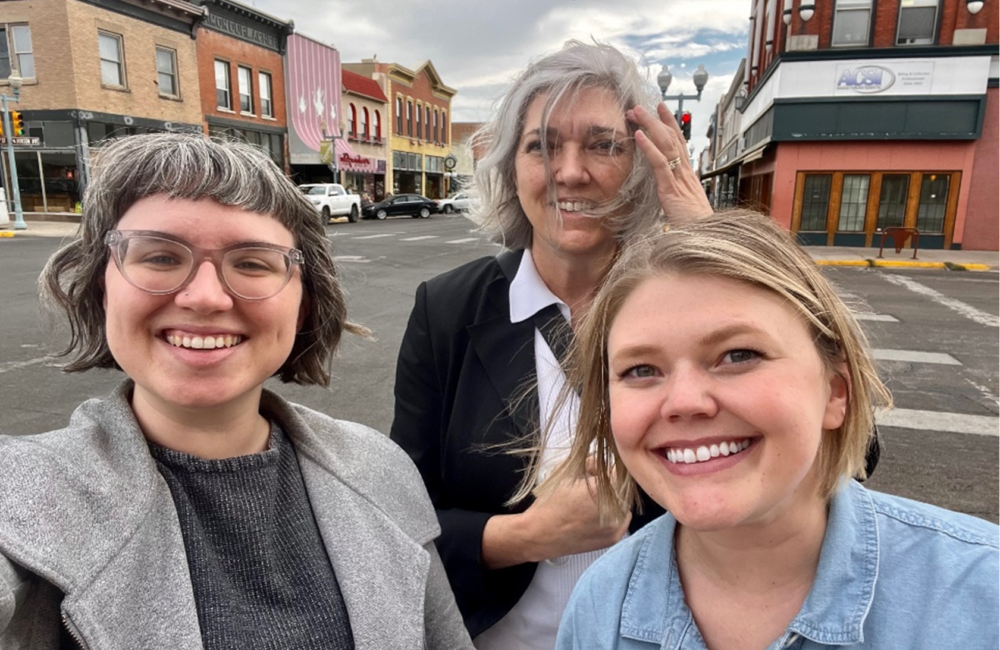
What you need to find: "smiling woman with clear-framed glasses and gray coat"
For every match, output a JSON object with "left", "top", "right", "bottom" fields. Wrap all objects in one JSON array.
[{"left": 0, "top": 135, "right": 471, "bottom": 650}]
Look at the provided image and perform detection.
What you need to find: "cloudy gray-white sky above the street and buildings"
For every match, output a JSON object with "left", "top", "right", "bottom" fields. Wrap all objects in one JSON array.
[{"left": 252, "top": 0, "right": 750, "bottom": 153}]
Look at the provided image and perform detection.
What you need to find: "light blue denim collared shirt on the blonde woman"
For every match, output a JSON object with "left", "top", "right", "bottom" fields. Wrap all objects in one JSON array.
[{"left": 556, "top": 481, "right": 1000, "bottom": 650}]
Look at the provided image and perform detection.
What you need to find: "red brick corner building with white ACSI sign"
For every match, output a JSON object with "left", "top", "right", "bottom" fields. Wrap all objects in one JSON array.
[{"left": 707, "top": 0, "right": 1000, "bottom": 250}]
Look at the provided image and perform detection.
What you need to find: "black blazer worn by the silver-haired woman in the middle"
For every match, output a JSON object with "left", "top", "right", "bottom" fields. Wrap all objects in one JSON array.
[{"left": 390, "top": 251, "right": 663, "bottom": 637}]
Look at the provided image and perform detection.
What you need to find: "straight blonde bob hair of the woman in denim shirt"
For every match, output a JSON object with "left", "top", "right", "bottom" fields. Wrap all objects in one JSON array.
[{"left": 526, "top": 211, "right": 892, "bottom": 516}]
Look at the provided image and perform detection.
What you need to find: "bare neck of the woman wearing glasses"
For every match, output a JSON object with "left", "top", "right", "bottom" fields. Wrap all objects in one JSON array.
[{"left": 132, "top": 387, "right": 271, "bottom": 460}]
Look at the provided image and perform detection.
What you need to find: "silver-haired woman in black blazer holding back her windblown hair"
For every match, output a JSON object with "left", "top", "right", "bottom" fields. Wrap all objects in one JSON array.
[{"left": 391, "top": 42, "right": 711, "bottom": 650}]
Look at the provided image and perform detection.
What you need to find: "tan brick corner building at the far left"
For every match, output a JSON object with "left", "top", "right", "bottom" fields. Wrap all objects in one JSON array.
[{"left": 0, "top": 0, "right": 205, "bottom": 212}]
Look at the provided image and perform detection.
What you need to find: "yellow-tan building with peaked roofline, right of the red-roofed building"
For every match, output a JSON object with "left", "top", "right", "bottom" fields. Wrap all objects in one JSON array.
[{"left": 344, "top": 59, "right": 456, "bottom": 198}]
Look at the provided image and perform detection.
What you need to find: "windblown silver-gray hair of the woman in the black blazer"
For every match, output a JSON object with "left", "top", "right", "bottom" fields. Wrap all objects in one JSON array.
[{"left": 472, "top": 41, "right": 662, "bottom": 248}]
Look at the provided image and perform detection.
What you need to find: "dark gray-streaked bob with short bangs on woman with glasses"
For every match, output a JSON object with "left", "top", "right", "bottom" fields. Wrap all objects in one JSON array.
[{"left": 40, "top": 133, "right": 354, "bottom": 386}]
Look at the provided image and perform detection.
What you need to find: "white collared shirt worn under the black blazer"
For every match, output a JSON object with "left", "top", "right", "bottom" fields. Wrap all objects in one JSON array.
[{"left": 474, "top": 249, "right": 604, "bottom": 650}]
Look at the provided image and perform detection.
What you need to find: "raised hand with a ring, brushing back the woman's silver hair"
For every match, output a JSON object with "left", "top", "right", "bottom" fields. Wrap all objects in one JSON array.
[{"left": 625, "top": 102, "right": 712, "bottom": 221}]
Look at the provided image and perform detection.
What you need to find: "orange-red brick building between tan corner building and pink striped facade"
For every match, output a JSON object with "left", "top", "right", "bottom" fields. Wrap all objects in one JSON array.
[{"left": 193, "top": 0, "right": 293, "bottom": 171}]
